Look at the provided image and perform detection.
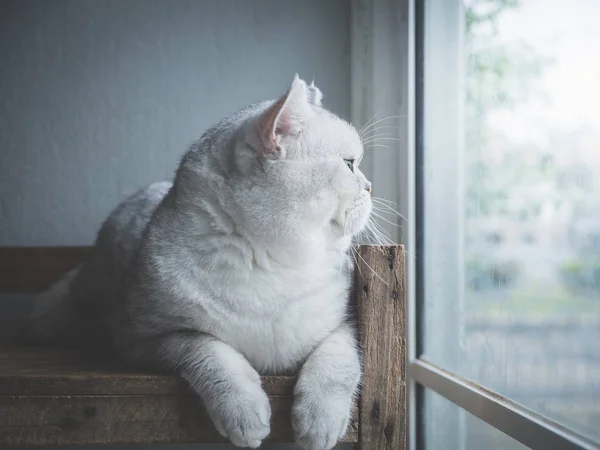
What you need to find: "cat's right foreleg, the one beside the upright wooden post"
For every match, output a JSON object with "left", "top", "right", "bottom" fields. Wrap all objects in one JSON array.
[{"left": 292, "top": 325, "right": 361, "bottom": 450}]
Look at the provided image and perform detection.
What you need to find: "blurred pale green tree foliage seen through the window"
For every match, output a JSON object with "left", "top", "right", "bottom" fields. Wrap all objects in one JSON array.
[{"left": 464, "top": 0, "right": 548, "bottom": 217}]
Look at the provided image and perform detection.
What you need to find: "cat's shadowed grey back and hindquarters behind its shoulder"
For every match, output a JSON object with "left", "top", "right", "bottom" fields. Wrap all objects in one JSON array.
[{"left": 27, "top": 182, "right": 171, "bottom": 343}]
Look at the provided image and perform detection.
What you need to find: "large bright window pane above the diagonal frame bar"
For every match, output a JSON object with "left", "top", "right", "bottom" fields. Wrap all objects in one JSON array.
[{"left": 422, "top": 0, "right": 600, "bottom": 442}]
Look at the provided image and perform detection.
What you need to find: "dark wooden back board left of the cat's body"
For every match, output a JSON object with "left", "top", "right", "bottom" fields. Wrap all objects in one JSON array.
[{"left": 0, "top": 247, "right": 92, "bottom": 293}]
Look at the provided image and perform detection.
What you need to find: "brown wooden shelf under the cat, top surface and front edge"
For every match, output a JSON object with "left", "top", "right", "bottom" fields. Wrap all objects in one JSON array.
[{"left": 0, "top": 346, "right": 358, "bottom": 446}]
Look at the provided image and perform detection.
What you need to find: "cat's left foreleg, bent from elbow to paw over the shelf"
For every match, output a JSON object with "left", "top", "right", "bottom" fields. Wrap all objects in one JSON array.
[{"left": 127, "top": 332, "right": 271, "bottom": 448}]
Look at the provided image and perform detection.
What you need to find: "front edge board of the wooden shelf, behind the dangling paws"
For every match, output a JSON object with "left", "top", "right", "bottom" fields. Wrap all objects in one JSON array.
[{"left": 0, "top": 392, "right": 358, "bottom": 446}]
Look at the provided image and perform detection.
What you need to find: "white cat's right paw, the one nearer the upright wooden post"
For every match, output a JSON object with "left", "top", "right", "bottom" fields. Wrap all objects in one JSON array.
[{"left": 292, "top": 391, "right": 352, "bottom": 450}]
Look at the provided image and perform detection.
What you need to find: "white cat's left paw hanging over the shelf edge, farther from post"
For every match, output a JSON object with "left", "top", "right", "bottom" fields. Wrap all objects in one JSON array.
[{"left": 208, "top": 381, "right": 271, "bottom": 448}]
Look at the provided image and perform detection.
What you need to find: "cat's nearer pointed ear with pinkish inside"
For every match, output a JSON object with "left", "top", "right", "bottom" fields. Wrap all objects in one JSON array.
[{"left": 257, "top": 75, "right": 312, "bottom": 159}]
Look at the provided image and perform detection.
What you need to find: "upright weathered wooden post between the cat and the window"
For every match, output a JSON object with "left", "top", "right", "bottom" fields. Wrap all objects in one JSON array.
[{"left": 356, "top": 245, "right": 407, "bottom": 450}]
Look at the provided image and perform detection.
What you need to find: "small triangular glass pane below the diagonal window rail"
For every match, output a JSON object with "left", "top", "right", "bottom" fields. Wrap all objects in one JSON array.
[{"left": 423, "top": 390, "right": 528, "bottom": 450}]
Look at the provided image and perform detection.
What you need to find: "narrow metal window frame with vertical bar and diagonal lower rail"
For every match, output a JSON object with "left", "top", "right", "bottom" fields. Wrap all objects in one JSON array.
[{"left": 404, "top": 0, "right": 600, "bottom": 450}]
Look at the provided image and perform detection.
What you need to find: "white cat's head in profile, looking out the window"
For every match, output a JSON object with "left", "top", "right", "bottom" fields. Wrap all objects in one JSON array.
[{"left": 183, "top": 76, "right": 371, "bottom": 250}]
